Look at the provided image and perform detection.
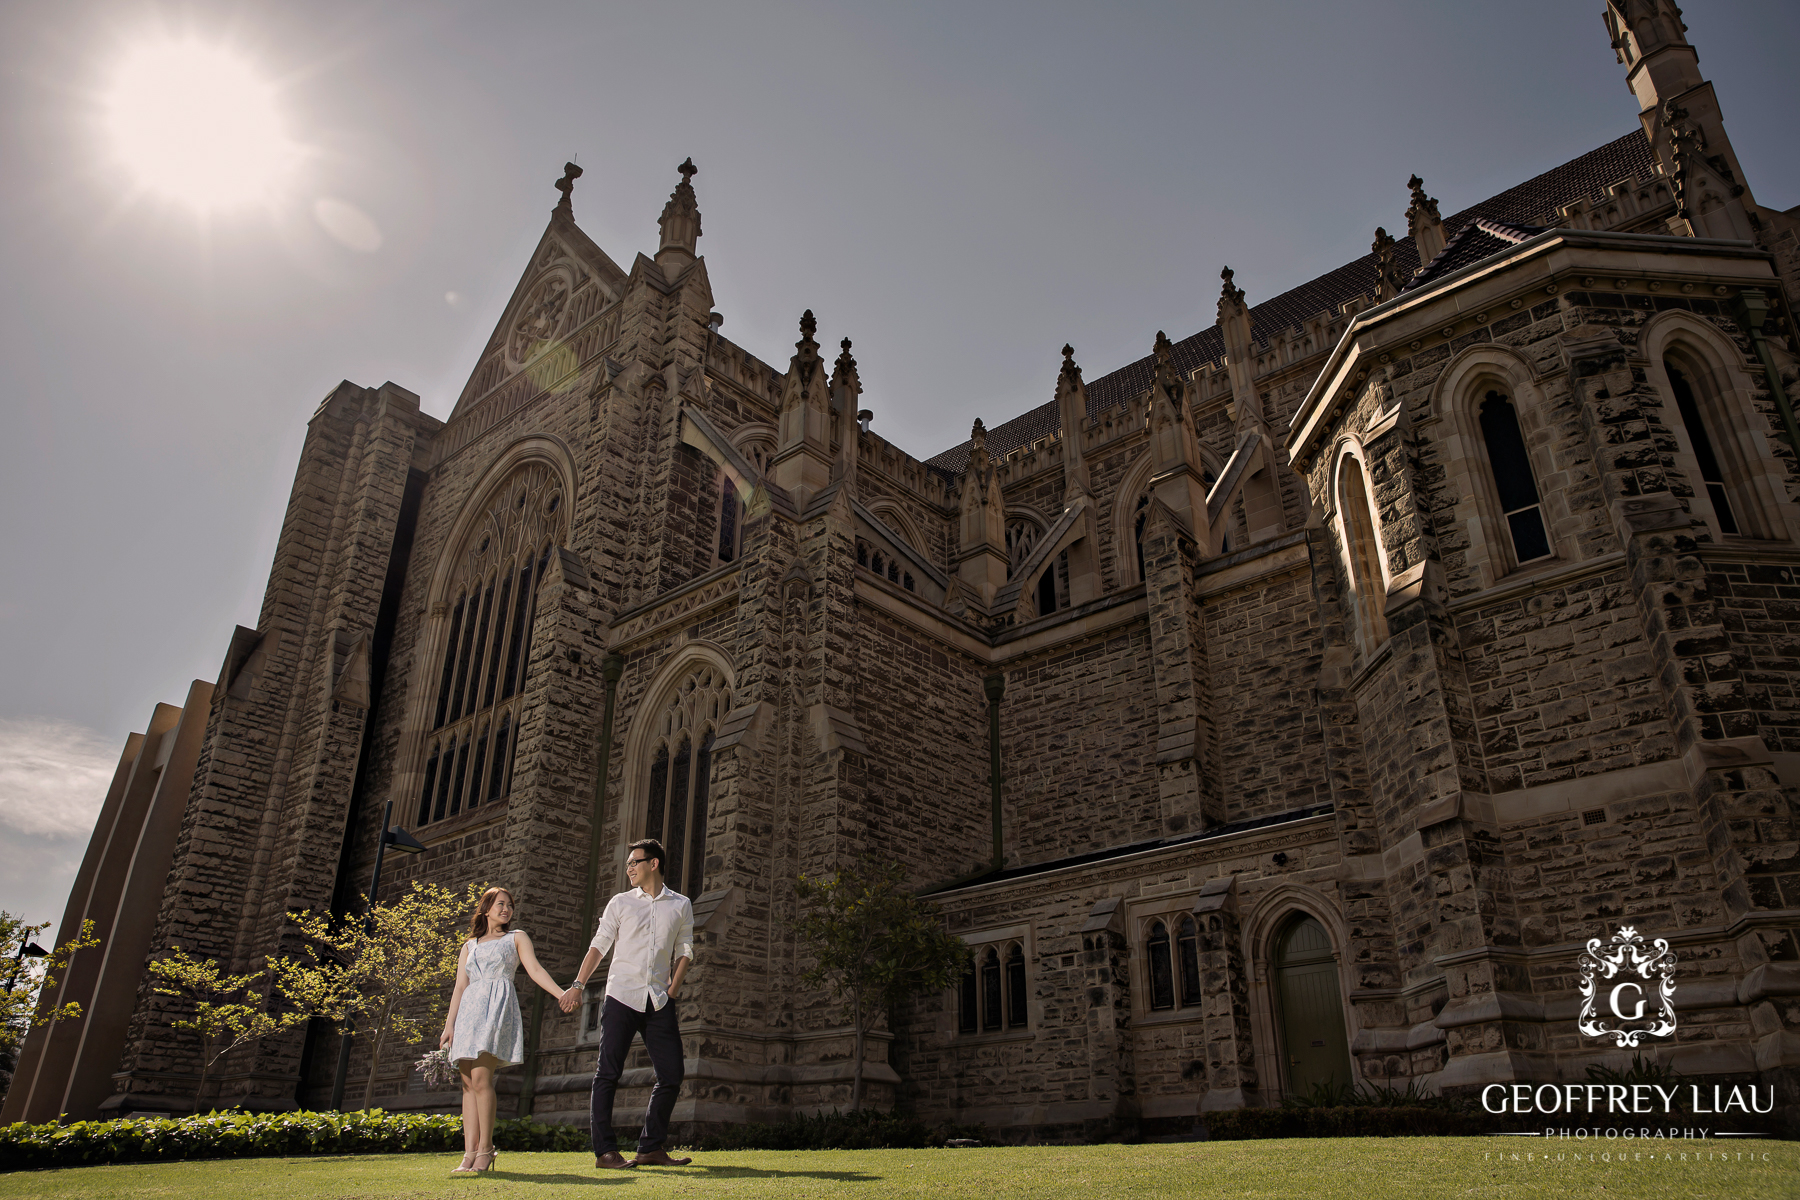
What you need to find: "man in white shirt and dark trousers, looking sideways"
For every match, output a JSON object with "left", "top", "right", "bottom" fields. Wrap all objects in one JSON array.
[{"left": 562, "top": 838, "right": 693, "bottom": 1168}]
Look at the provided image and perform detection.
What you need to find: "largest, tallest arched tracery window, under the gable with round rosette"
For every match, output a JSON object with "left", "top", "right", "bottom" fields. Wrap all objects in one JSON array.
[{"left": 418, "top": 462, "right": 567, "bottom": 826}]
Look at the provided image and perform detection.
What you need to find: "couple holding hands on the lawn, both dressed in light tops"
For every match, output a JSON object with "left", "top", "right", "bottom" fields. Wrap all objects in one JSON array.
[{"left": 439, "top": 838, "right": 693, "bottom": 1175}]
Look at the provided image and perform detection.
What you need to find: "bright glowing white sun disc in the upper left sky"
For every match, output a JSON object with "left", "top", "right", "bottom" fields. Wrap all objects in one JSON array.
[{"left": 104, "top": 40, "right": 301, "bottom": 212}]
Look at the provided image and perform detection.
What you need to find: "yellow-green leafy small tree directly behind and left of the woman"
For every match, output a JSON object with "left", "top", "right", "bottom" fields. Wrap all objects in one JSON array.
[{"left": 268, "top": 882, "right": 482, "bottom": 1108}]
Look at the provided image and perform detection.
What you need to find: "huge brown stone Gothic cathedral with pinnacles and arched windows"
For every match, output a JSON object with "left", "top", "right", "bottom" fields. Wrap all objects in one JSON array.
[{"left": 10, "top": 0, "right": 1800, "bottom": 1139}]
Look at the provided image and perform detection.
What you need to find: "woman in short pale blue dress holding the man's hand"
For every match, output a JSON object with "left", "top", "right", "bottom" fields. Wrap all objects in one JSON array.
[{"left": 437, "top": 887, "right": 563, "bottom": 1175}]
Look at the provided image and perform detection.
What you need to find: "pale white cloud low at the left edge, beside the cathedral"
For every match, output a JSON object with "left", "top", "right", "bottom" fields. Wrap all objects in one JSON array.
[{"left": 0, "top": 718, "right": 119, "bottom": 838}]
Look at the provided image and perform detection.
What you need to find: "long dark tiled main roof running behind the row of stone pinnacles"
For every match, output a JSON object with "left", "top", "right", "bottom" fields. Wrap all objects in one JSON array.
[{"left": 925, "top": 130, "right": 1656, "bottom": 475}]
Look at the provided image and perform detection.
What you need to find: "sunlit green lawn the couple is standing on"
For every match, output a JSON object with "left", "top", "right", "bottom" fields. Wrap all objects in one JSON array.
[{"left": 0, "top": 1137, "right": 1800, "bottom": 1200}]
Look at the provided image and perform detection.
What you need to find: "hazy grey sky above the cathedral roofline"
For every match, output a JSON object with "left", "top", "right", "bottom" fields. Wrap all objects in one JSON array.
[{"left": 0, "top": 0, "right": 1800, "bottom": 921}]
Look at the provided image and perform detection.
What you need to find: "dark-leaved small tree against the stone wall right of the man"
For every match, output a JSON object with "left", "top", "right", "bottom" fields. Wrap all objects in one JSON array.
[{"left": 794, "top": 860, "right": 968, "bottom": 1108}]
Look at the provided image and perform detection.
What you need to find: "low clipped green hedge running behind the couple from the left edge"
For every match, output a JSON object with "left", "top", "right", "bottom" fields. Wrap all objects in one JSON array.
[{"left": 0, "top": 1108, "right": 589, "bottom": 1171}]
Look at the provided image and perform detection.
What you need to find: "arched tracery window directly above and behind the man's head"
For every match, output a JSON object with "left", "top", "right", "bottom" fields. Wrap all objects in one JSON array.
[{"left": 644, "top": 664, "right": 731, "bottom": 896}]
